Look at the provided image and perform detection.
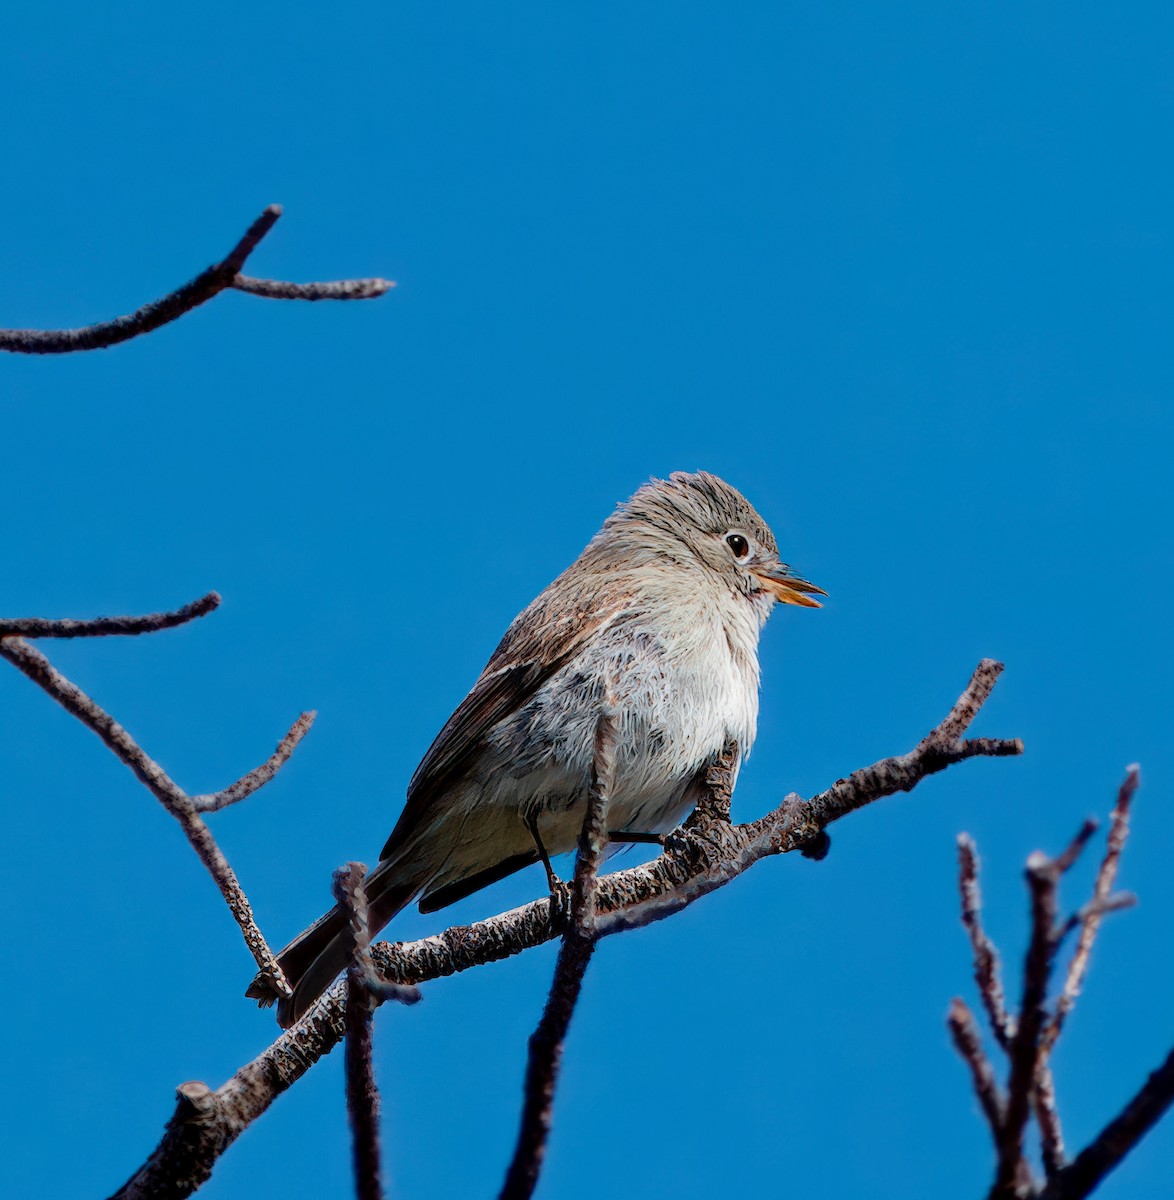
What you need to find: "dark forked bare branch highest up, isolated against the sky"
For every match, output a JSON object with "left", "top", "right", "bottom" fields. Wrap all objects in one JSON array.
[{"left": 0, "top": 204, "right": 393, "bottom": 354}]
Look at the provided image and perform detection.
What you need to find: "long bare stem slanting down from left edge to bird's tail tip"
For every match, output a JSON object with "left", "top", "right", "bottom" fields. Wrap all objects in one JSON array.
[{"left": 0, "top": 637, "right": 289, "bottom": 995}]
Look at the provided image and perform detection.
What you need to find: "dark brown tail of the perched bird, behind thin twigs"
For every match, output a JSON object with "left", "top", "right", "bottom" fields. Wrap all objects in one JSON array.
[{"left": 245, "top": 859, "right": 419, "bottom": 1030}]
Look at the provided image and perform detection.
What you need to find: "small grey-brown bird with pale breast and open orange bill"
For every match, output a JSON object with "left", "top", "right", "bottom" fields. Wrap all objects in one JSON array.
[{"left": 246, "top": 470, "right": 827, "bottom": 1027}]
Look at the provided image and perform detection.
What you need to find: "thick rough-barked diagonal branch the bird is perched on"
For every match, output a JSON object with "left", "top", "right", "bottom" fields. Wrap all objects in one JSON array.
[{"left": 116, "top": 659, "right": 1023, "bottom": 1200}]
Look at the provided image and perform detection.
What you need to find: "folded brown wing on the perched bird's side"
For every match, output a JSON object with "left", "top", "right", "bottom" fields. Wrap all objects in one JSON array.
[{"left": 379, "top": 573, "right": 629, "bottom": 858}]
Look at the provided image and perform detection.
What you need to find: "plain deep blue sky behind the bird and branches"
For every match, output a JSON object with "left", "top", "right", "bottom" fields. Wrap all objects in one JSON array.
[{"left": 0, "top": 0, "right": 1174, "bottom": 1200}]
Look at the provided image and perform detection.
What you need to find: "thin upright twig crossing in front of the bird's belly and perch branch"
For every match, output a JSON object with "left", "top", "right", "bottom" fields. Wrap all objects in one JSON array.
[{"left": 501, "top": 706, "right": 616, "bottom": 1200}]
